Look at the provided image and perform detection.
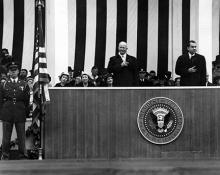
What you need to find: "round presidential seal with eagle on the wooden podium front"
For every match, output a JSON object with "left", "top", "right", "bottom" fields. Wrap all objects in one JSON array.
[{"left": 137, "top": 97, "right": 184, "bottom": 144}]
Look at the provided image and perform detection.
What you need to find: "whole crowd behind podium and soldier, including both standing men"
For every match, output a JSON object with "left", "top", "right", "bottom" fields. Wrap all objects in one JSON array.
[{"left": 0, "top": 41, "right": 220, "bottom": 88}]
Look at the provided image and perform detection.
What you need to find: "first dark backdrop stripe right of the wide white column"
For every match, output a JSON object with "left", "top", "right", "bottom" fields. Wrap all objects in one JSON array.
[{"left": 74, "top": 0, "right": 86, "bottom": 70}]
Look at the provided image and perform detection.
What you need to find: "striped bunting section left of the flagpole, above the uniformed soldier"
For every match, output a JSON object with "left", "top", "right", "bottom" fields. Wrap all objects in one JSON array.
[{"left": 0, "top": 0, "right": 35, "bottom": 70}]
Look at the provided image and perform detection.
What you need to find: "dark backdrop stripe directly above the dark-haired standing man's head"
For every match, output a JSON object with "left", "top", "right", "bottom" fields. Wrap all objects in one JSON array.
[{"left": 182, "top": 0, "right": 190, "bottom": 53}]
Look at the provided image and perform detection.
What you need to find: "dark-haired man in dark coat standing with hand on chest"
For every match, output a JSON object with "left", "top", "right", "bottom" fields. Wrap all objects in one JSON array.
[{"left": 175, "top": 40, "right": 206, "bottom": 86}]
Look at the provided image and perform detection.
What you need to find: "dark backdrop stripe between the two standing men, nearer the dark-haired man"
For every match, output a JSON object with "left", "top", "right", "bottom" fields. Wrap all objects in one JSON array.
[{"left": 157, "top": 0, "right": 169, "bottom": 76}]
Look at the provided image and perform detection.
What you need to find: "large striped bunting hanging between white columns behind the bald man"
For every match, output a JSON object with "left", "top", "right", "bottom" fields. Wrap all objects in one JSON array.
[{"left": 55, "top": 0, "right": 194, "bottom": 80}]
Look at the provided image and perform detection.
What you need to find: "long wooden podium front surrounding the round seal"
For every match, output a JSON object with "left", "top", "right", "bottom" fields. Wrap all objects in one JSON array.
[{"left": 44, "top": 88, "right": 220, "bottom": 160}]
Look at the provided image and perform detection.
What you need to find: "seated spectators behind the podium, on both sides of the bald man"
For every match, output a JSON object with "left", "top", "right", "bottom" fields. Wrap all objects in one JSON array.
[{"left": 55, "top": 66, "right": 183, "bottom": 87}]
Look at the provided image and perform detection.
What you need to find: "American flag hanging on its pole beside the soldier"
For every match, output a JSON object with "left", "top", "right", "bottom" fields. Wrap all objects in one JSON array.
[{"left": 32, "top": 0, "right": 50, "bottom": 123}]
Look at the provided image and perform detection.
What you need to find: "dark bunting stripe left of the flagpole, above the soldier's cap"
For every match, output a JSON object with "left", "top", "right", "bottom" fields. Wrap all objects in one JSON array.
[{"left": 12, "top": 0, "right": 24, "bottom": 64}]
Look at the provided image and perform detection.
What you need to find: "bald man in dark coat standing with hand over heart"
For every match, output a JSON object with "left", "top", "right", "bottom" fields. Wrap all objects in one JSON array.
[{"left": 108, "top": 41, "right": 138, "bottom": 86}]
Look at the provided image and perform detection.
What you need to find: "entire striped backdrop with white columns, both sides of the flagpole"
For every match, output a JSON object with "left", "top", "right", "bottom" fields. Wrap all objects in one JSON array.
[{"left": 0, "top": 0, "right": 219, "bottom": 83}]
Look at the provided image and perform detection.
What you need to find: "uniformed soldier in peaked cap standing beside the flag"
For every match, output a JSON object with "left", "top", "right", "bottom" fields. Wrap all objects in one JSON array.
[{"left": 0, "top": 62, "right": 29, "bottom": 160}]
